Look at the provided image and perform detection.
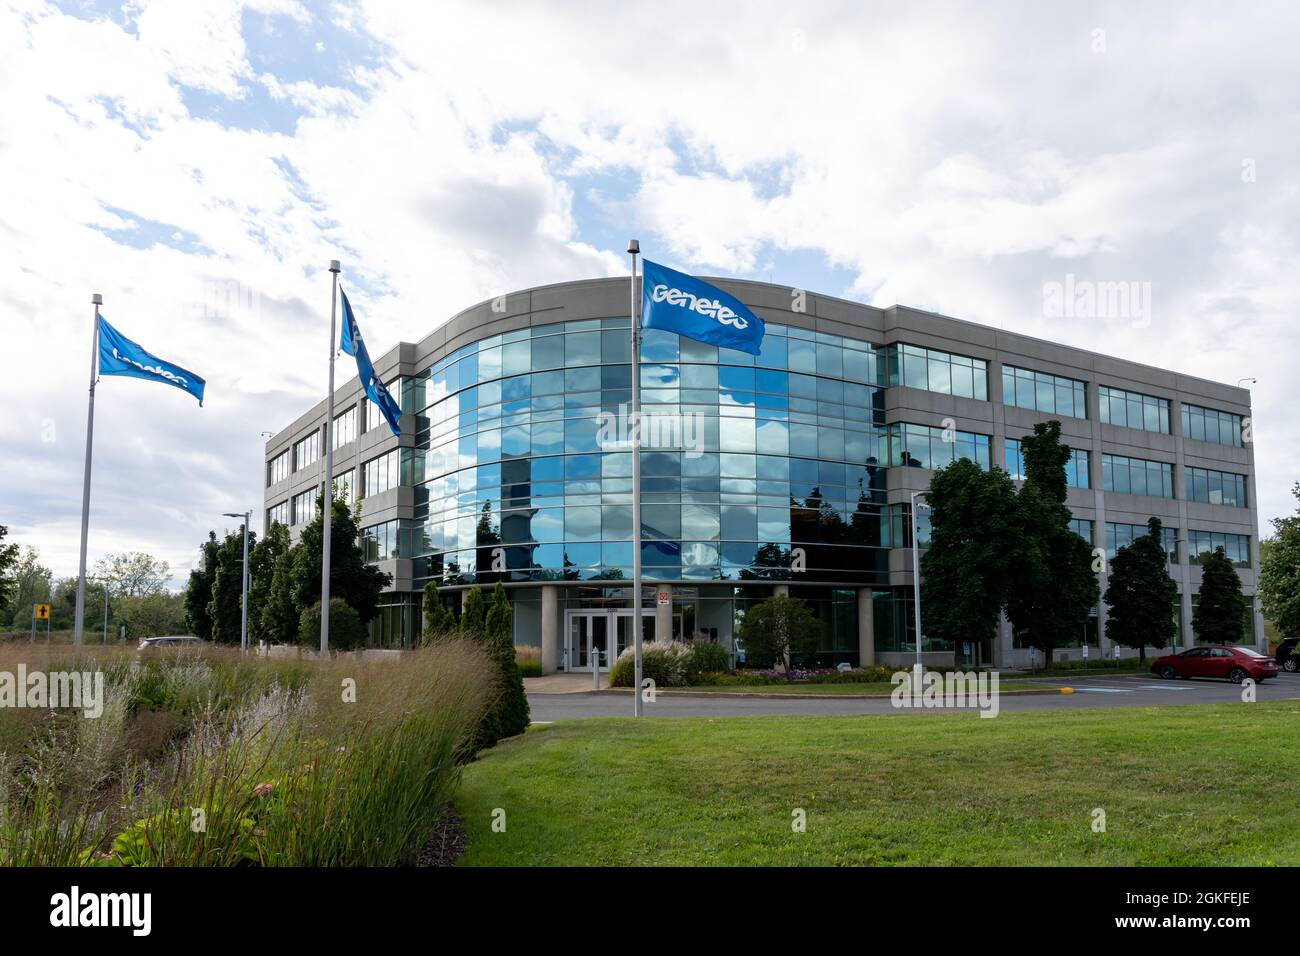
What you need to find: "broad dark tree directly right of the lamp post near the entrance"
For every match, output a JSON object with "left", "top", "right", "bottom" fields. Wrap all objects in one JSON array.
[{"left": 920, "top": 458, "right": 1018, "bottom": 663}]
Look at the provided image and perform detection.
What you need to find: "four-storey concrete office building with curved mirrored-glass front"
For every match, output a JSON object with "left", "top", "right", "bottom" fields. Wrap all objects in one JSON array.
[{"left": 258, "top": 280, "right": 1255, "bottom": 670}]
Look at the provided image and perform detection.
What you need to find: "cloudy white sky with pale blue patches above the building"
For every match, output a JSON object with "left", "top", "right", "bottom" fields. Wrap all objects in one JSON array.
[{"left": 0, "top": 0, "right": 1300, "bottom": 584}]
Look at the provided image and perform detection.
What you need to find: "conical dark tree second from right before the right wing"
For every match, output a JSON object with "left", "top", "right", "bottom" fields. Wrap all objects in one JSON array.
[{"left": 1105, "top": 518, "right": 1178, "bottom": 661}]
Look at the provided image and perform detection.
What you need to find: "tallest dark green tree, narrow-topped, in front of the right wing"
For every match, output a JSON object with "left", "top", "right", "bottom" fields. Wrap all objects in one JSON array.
[{"left": 1006, "top": 421, "right": 1101, "bottom": 662}]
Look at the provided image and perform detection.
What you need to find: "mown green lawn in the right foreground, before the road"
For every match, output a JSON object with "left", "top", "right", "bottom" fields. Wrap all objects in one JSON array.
[{"left": 456, "top": 701, "right": 1300, "bottom": 866}]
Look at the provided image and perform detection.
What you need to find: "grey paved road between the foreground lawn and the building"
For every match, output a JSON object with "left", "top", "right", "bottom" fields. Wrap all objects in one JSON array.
[{"left": 528, "top": 674, "right": 1300, "bottom": 722}]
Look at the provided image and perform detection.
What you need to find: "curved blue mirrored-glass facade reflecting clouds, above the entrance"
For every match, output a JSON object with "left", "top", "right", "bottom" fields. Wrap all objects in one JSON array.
[{"left": 403, "top": 317, "right": 925, "bottom": 584}]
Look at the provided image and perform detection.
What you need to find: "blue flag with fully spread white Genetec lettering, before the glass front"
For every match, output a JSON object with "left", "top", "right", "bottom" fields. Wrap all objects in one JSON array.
[{"left": 641, "top": 259, "right": 764, "bottom": 355}]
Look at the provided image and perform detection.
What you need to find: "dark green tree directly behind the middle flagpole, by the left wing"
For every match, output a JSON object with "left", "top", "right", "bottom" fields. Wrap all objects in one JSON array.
[{"left": 293, "top": 497, "right": 393, "bottom": 624}]
